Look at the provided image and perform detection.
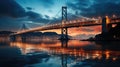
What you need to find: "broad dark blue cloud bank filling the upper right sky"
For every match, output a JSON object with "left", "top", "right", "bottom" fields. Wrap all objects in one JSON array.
[{"left": 68, "top": 0, "right": 120, "bottom": 17}]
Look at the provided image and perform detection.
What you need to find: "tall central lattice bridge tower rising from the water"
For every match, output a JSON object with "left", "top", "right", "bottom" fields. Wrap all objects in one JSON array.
[{"left": 60, "top": 6, "right": 68, "bottom": 40}]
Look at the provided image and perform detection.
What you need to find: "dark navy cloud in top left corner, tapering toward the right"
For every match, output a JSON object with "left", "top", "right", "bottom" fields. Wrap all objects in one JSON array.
[{"left": 0, "top": 0, "right": 49, "bottom": 21}]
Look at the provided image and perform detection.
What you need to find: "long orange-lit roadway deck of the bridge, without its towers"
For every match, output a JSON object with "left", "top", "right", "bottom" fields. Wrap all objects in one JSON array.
[{"left": 11, "top": 18, "right": 120, "bottom": 35}]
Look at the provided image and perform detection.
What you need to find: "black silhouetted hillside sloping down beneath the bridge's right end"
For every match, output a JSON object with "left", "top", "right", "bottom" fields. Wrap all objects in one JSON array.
[{"left": 82, "top": 23, "right": 120, "bottom": 41}]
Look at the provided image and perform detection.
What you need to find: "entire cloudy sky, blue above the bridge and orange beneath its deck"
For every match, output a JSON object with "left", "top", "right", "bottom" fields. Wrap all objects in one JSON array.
[{"left": 0, "top": 0, "right": 120, "bottom": 38}]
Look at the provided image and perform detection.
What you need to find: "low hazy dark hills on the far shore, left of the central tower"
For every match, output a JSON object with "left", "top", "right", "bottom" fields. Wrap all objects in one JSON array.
[{"left": 0, "top": 31, "right": 71, "bottom": 41}]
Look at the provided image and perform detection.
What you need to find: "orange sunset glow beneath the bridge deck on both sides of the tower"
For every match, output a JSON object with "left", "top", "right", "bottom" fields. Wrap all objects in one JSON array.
[{"left": 42, "top": 26, "right": 101, "bottom": 36}]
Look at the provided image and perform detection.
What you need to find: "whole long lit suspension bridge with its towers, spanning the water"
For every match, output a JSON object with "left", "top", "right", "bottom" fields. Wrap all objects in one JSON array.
[{"left": 10, "top": 6, "right": 120, "bottom": 40}]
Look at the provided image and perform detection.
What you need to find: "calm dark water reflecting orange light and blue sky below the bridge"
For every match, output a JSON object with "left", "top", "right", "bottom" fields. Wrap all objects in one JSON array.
[{"left": 0, "top": 40, "right": 120, "bottom": 67}]
